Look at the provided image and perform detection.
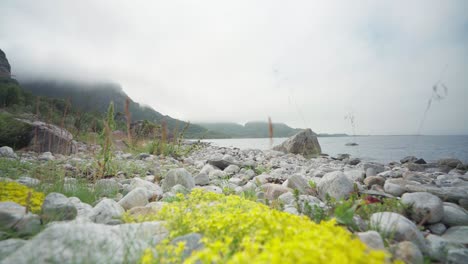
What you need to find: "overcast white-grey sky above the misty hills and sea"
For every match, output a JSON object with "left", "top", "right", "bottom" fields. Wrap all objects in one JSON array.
[{"left": 0, "top": 0, "right": 468, "bottom": 134}]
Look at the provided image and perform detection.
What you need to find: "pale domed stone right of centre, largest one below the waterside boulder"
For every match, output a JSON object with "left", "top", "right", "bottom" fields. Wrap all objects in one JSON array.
[{"left": 317, "top": 171, "right": 354, "bottom": 200}]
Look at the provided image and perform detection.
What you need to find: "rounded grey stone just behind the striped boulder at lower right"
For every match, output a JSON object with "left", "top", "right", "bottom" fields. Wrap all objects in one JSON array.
[{"left": 401, "top": 192, "right": 444, "bottom": 224}]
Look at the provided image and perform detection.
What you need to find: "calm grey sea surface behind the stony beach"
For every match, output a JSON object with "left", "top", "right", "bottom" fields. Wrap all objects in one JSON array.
[{"left": 204, "top": 136, "right": 468, "bottom": 163}]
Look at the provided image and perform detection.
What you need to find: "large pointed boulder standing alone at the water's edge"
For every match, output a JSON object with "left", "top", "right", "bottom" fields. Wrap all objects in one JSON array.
[{"left": 273, "top": 128, "right": 322, "bottom": 157}]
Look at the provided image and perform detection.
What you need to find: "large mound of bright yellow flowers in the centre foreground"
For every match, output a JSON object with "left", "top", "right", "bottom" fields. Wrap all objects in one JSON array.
[{"left": 124, "top": 189, "right": 389, "bottom": 263}]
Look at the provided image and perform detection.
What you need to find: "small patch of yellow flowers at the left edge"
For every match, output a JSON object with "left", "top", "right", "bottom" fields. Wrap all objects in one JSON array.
[{"left": 0, "top": 181, "right": 45, "bottom": 213}]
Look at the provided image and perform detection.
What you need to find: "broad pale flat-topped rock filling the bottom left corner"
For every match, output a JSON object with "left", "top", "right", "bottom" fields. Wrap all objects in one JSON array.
[{"left": 3, "top": 222, "right": 168, "bottom": 263}]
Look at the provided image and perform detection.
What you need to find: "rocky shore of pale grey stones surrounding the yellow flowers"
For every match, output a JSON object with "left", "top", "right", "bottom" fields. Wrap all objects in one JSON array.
[{"left": 0, "top": 130, "right": 468, "bottom": 263}]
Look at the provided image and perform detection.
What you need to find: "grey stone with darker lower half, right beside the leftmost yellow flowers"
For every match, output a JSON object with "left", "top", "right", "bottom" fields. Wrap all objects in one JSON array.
[{"left": 42, "top": 193, "right": 78, "bottom": 223}]
